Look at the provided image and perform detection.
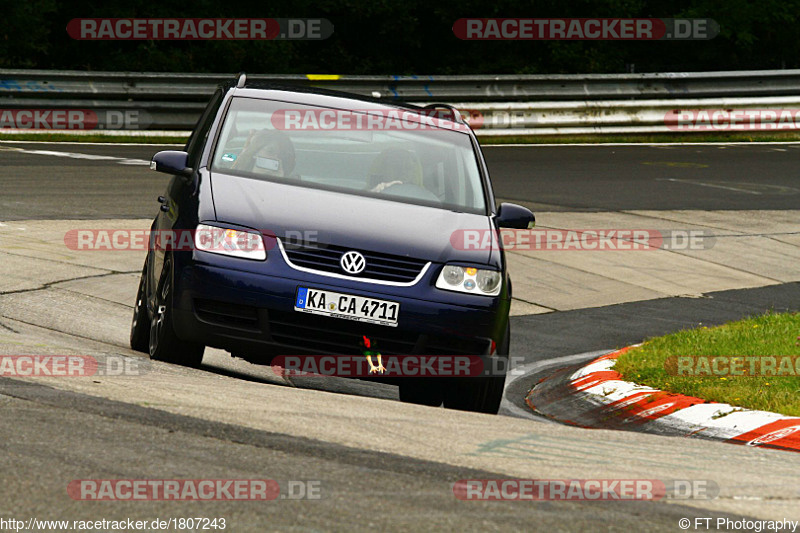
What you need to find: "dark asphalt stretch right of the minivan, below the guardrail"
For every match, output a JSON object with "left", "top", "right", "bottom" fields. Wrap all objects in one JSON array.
[{"left": 484, "top": 143, "right": 800, "bottom": 211}]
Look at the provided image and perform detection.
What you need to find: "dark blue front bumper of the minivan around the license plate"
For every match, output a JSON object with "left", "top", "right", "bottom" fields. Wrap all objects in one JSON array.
[{"left": 173, "top": 261, "right": 509, "bottom": 358}]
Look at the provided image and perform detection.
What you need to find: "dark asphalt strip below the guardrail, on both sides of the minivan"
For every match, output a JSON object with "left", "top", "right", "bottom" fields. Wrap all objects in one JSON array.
[{"left": 0, "top": 142, "right": 800, "bottom": 220}]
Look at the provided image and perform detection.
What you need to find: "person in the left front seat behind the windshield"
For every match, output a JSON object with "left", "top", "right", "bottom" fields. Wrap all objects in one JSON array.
[{"left": 233, "top": 130, "right": 295, "bottom": 178}]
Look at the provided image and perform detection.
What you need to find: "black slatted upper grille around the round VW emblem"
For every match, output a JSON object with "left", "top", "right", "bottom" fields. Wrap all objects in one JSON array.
[{"left": 284, "top": 242, "right": 427, "bottom": 283}]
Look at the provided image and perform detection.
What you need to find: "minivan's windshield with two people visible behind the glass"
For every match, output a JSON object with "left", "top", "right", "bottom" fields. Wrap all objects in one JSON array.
[{"left": 211, "top": 97, "right": 486, "bottom": 214}]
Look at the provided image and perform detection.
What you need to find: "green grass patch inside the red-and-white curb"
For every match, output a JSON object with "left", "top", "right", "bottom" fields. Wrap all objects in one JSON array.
[{"left": 615, "top": 313, "right": 800, "bottom": 416}]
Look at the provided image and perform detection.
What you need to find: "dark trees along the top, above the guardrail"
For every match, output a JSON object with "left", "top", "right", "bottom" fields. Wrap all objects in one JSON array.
[{"left": 0, "top": 0, "right": 800, "bottom": 75}]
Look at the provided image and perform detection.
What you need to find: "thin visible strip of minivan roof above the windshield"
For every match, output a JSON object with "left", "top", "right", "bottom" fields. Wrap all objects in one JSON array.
[{"left": 227, "top": 82, "right": 468, "bottom": 133}]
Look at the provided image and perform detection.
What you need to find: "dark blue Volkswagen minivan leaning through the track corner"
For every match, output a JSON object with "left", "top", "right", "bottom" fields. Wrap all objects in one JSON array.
[{"left": 131, "top": 75, "right": 534, "bottom": 413}]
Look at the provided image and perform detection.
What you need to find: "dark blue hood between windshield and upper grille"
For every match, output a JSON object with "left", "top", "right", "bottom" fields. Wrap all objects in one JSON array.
[{"left": 211, "top": 172, "right": 491, "bottom": 264}]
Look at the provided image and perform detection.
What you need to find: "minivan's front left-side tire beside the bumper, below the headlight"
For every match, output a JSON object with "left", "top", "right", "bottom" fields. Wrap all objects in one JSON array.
[{"left": 149, "top": 256, "right": 205, "bottom": 367}]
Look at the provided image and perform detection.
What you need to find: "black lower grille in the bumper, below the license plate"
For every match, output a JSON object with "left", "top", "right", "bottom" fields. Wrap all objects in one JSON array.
[{"left": 269, "top": 311, "right": 489, "bottom": 355}]
